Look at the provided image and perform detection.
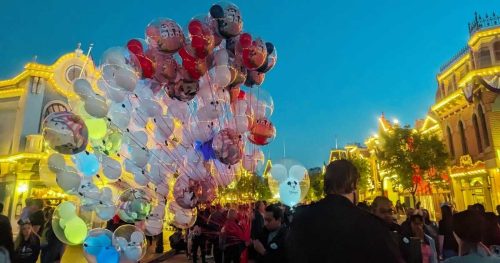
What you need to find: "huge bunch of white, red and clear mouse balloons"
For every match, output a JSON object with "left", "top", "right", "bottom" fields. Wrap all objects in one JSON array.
[{"left": 40, "top": 3, "right": 277, "bottom": 261}]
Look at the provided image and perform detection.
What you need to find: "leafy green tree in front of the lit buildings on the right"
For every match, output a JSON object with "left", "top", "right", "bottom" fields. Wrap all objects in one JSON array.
[{"left": 377, "top": 126, "right": 448, "bottom": 202}]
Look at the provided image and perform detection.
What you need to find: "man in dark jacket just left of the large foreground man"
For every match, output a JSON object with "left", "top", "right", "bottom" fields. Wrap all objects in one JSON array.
[{"left": 253, "top": 205, "right": 287, "bottom": 263}]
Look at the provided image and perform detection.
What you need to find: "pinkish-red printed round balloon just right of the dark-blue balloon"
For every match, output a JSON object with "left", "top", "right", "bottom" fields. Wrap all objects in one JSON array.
[{"left": 212, "top": 128, "right": 243, "bottom": 165}]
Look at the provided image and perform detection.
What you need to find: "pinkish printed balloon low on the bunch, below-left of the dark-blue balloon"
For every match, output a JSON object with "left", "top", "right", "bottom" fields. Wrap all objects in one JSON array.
[{"left": 174, "top": 175, "right": 202, "bottom": 209}]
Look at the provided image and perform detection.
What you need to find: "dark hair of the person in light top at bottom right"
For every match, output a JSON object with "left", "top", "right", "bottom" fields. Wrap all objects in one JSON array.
[{"left": 453, "top": 210, "right": 483, "bottom": 243}]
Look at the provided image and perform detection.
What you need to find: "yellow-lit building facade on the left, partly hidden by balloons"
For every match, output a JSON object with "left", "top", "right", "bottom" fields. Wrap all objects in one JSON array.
[{"left": 0, "top": 48, "right": 101, "bottom": 232}]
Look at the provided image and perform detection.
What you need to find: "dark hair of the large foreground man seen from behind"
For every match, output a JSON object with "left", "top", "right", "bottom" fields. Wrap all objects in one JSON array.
[{"left": 324, "top": 160, "right": 359, "bottom": 194}]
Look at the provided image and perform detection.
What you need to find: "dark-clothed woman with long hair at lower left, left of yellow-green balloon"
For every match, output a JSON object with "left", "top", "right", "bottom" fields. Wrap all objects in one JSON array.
[{"left": 14, "top": 221, "right": 40, "bottom": 263}]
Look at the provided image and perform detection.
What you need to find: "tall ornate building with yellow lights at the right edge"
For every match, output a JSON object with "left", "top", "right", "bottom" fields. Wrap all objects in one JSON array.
[{"left": 431, "top": 14, "right": 500, "bottom": 211}]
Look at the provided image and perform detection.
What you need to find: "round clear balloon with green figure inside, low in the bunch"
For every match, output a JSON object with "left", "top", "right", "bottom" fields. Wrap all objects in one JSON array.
[{"left": 118, "top": 188, "right": 151, "bottom": 223}]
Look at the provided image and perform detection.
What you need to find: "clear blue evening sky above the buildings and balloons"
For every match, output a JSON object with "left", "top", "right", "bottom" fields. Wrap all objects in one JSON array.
[{"left": 0, "top": 0, "right": 494, "bottom": 167}]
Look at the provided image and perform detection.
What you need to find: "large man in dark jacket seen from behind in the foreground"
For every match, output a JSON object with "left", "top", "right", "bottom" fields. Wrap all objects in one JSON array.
[{"left": 287, "top": 160, "right": 403, "bottom": 263}]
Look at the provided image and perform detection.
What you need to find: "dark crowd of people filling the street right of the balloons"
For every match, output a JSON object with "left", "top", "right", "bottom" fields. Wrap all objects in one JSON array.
[{"left": 174, "top": 160, "right": 500, "bottom": 263}]
